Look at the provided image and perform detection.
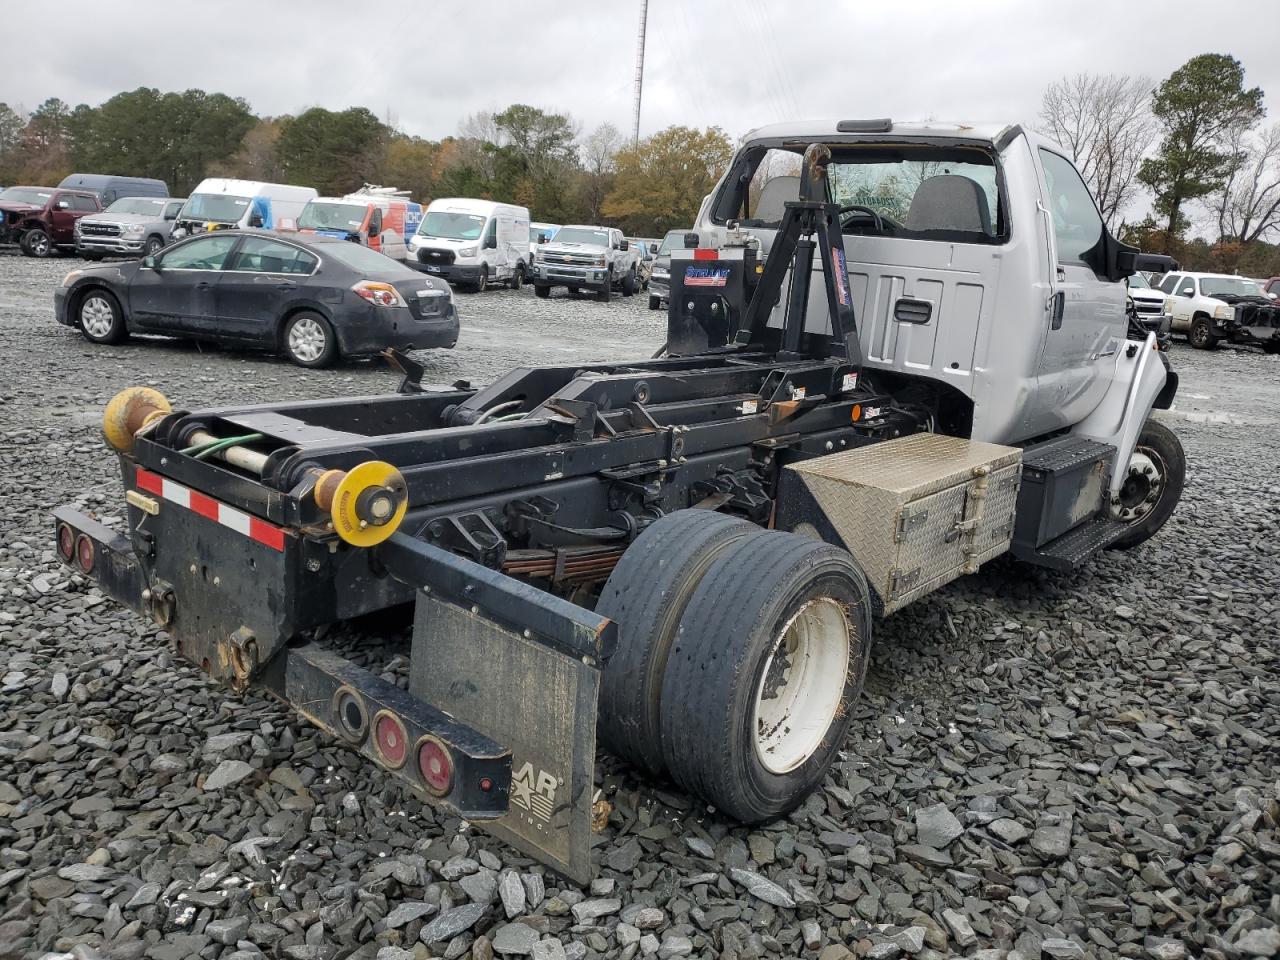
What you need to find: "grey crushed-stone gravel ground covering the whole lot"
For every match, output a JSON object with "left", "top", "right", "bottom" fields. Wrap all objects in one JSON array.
[{"left": 0, "top": 256, "right": 1280, "bottom": 960}]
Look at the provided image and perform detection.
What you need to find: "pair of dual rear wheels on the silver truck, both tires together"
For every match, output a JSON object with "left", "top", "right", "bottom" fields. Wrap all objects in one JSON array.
[{"left": 596, "top": 509, "right": 870, "bottom": 823}]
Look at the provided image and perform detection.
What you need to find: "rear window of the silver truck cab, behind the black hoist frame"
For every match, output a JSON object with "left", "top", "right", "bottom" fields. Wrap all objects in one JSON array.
[{"left": 714, "top": 143, "right": 1007, "bottom": 243}]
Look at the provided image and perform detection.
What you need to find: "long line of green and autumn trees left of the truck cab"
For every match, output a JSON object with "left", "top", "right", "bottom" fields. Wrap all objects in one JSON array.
[{"left": 0, "top": 87, "right": 733, "bottom": 236}]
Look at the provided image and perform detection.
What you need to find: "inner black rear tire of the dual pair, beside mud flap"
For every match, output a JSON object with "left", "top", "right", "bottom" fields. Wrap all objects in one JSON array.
[{"left": 595, "top": 509, "right": 759, "bottom": 774}]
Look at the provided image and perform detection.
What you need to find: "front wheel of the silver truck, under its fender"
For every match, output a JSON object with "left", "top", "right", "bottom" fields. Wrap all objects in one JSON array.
[{"left": 1111, "top": 420, "right": 1187, "bottom": 550}]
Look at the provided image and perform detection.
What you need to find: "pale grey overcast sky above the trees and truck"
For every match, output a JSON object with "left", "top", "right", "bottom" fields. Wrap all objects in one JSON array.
[{"left": 0, "top": 0, "right": 1280, "bottom": 145}]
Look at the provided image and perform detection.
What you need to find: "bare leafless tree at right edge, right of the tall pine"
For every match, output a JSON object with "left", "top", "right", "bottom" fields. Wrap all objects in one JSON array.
[{"left": 1208, "top": 123, "right": 1280, "bottom": 243}]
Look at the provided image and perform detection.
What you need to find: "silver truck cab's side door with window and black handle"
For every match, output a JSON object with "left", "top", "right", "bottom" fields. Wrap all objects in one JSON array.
[{"left": 1025, "top": 147, "right": 1125, "bottom": 435}]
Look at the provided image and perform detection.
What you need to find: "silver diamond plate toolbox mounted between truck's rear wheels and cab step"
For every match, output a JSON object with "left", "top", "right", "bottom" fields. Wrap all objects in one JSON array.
[{"left": 777, "top": 434, "right": 1021, "bottom": 613}]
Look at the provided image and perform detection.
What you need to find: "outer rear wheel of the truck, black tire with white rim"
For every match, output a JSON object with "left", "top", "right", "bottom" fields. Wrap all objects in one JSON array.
[{"left": 662, "top": 530, "right": 872, "bottom": 823}]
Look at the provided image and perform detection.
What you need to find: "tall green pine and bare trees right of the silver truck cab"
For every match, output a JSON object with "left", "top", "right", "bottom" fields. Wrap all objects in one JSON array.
[{"left": 1039, "top": 54, "right": 1280, "bottom": 276}]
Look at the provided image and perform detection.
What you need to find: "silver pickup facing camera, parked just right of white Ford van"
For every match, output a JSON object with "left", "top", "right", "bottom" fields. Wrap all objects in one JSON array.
[{"left": 534, "top": 227, "right": 640, "bottom": 303}]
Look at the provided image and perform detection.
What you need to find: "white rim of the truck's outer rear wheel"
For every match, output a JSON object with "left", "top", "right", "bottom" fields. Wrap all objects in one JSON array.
[{"left": 751, "top": 596, "right": 851, "bottom": 774}]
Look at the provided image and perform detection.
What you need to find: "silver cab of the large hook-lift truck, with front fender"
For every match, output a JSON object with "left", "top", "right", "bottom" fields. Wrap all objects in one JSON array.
[{"left": 695, "top": 120, "right": 1176, "bottom": 490}]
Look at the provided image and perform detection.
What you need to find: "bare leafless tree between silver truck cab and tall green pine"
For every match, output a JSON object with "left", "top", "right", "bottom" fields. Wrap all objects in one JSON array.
[{"left": 1041, "top": 73, "right": 1158, "bottom": 232}]
